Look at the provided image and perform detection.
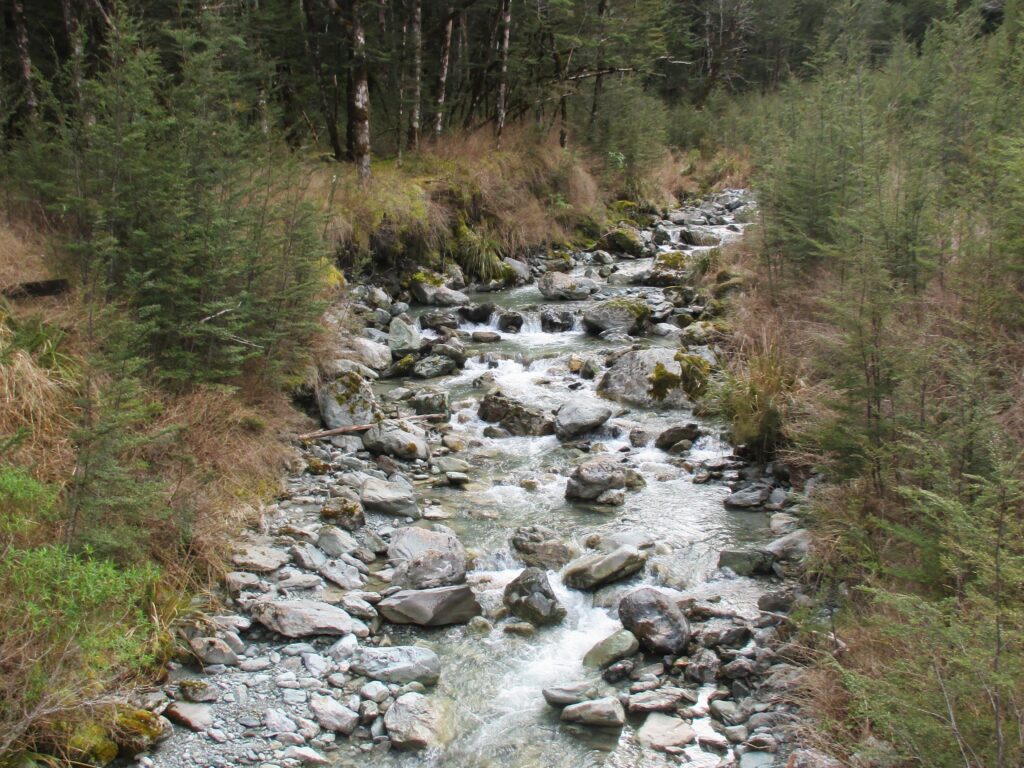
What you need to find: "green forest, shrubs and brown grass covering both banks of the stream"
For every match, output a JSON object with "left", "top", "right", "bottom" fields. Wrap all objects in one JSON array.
[{"left": 0, "top": 0, "right": 1024, "bottom": 768}]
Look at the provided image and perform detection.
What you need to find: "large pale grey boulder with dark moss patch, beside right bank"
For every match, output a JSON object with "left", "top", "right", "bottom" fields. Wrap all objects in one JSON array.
[{"left": 597, "top": 347, "right": 689, "bottom": 408}]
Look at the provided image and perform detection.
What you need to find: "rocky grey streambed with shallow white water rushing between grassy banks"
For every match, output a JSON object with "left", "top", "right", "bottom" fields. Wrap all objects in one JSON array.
[{"left": 136, "top": 190, "right": 831, "bottom": 768}]
